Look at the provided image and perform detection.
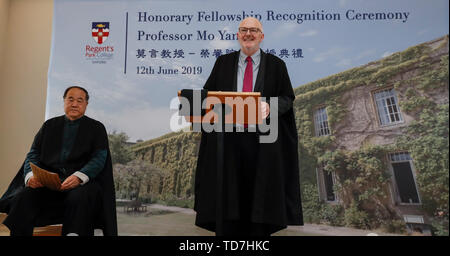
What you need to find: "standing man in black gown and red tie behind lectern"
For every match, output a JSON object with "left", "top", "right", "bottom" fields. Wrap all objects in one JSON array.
[{"left": 194, "top": 17, "right": 303, "bottom": 236}]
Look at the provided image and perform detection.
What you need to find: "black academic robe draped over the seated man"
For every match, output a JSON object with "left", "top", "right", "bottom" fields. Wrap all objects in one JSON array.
[{"left": 0, "top": 116, "right": 117, "bottom": 236}]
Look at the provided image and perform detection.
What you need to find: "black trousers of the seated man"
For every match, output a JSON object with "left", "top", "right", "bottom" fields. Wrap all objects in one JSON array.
[{"left": 3, "top": 181, "right": 101, "bottom": 236}]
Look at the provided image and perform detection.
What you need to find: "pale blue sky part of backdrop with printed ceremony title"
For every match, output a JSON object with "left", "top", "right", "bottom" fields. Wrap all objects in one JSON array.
[{"left": 46, "top": 0, "right": 449, "bottom": 141}]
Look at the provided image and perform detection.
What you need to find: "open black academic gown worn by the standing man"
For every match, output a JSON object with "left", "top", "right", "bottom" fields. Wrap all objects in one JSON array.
[{"left": 194, "top": 51, "right": 303, "bottom": 233}]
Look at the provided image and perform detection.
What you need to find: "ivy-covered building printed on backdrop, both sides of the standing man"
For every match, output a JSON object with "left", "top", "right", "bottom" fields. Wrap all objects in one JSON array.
[{"left": 109, "top": 35, "right": 449, "bottom": 236}]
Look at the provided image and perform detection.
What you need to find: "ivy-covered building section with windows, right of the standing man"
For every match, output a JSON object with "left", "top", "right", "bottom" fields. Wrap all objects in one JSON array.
[{"left": 294, "top": 36, "right": 449, "bottom": 234}]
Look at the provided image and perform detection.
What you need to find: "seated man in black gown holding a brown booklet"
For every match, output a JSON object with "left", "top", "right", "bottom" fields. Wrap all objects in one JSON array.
[{"left": 0, "top": 86, "right": 117, "bottom": 236}]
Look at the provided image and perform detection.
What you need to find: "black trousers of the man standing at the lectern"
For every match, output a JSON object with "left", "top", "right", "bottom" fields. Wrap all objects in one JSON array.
[{"left": 216, "top": 132, "right": 271, "bottom": 236}]
